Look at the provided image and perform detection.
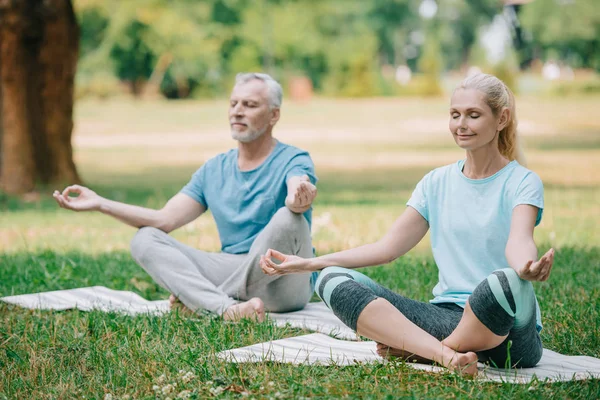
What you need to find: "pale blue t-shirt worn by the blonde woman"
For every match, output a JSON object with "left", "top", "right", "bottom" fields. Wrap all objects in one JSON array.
[{"left": 407, "top": 160, "right": 544, "bottom": 329}]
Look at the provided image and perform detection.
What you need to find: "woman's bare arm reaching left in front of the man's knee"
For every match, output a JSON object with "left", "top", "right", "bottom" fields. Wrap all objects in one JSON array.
[{"left": 261, "top": 207, "right": 429, "bottom": 275}]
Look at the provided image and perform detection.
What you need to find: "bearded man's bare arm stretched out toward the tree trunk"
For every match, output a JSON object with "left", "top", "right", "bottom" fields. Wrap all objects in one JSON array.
[{"left": 53, "top": 185, "right": 206, "bottom": 233}]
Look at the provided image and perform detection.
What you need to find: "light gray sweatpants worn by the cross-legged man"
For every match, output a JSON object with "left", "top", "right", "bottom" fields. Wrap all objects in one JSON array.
[{"left": 131, "top": 207, "right": 313, "bottom": 315}]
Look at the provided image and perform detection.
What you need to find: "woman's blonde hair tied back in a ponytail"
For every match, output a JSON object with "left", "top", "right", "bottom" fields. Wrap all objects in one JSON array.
[{"left": 454, "top": 73, "right": 525, "bottom": 165}]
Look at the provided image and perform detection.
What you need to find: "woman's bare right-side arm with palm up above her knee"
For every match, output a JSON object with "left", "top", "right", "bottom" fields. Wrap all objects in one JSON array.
[{"left": 505, "top": 204, "right": 554, "bottom": 281}]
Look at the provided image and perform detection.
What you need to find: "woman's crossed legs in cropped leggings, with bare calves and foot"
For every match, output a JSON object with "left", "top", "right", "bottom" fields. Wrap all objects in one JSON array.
[{"left": 316, "top": 267, "right": 541, "bottom": 374}]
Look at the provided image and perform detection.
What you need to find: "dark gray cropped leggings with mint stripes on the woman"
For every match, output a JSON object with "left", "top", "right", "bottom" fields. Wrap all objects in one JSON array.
[{"left": 315, "top": 267, "right": 543, "bottom": 368}]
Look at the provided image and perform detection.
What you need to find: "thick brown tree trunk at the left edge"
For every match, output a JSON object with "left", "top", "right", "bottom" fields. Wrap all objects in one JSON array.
[{"left": 0, "top": 0, "right": 80, "bottom": 194}]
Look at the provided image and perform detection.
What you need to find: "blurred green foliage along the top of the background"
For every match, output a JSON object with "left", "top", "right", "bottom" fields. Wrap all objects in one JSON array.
[{"left": 74, "top": 0, "right": 600, "bottom": 98}]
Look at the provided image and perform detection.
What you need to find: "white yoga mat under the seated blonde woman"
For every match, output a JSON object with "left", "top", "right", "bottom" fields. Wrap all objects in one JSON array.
[{"left": 217, "top": 333, "right": 600, "bottom": 383}]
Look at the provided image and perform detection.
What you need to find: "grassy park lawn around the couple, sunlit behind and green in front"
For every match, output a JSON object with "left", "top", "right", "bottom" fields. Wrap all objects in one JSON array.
[{"left": 0, "top": 97, "right": 600, "bottom": 399}]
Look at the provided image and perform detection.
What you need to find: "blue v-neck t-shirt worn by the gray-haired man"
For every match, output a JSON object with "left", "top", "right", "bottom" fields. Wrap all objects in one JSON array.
[{"left": 181, "top": 141, "right": 317, "bottom": 254}]
